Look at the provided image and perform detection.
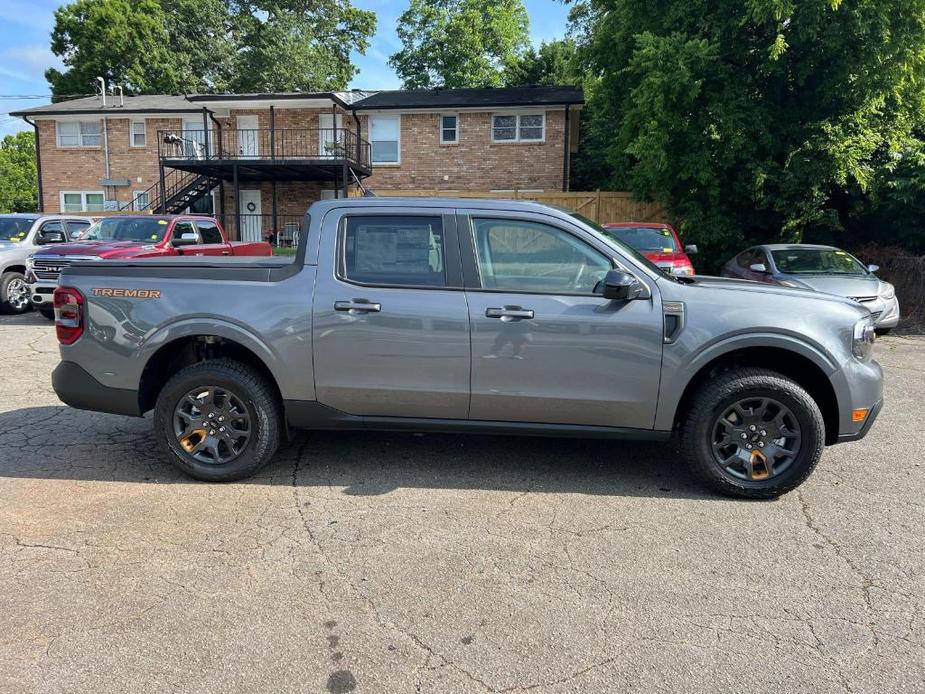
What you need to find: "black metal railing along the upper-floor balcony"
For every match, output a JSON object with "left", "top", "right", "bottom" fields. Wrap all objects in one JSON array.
[{"left": 157, "top": 128, "right": 370, "bottom": 166}]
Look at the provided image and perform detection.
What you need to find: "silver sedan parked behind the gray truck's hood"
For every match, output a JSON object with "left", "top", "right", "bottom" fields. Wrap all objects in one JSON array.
[{"left": 722, "top": 243, "right": 899, "bottom": 334}]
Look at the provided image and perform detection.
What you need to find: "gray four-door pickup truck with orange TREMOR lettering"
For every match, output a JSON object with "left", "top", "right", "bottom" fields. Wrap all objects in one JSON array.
[{"left": 53, "top": 198, "right": 882, "bottom": 498}]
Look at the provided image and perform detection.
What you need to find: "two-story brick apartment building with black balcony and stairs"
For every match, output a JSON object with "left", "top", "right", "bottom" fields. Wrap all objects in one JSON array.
[{"left": 12, "top": 87, "right": 583, "bottom": 240}]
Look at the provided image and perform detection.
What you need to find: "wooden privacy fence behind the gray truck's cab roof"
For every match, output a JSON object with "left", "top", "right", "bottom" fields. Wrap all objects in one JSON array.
[{"left": 358, "top": 188, "right": 668, "bottom": 224}]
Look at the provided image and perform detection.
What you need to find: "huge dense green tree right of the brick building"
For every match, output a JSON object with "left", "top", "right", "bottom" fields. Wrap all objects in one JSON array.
[{"left": 572, "top": 0, "right": 925, "bottom": 261}]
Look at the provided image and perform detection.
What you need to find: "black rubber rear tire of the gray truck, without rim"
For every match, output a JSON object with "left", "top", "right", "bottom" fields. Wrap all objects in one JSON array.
[{"left": 154, "top": 359, "right": 283, "bottom": 482}]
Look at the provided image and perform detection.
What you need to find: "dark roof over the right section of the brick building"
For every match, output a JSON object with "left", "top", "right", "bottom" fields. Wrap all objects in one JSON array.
[{"left": 353, "top": 86, "right": 585, "bottom": 110}]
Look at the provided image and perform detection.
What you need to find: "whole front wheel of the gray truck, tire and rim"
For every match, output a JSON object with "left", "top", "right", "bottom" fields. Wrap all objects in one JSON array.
[{"left": 681, "top": 368, "right": 825, "bottom": 499}]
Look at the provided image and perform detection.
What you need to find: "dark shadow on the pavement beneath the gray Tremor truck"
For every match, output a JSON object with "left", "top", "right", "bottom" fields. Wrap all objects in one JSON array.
[{"left": 0, "top": 406, "right": 716, "bottom": 499}]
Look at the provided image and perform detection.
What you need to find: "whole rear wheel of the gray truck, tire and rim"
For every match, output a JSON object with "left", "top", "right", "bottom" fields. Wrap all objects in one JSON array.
[{"left": 154, "top": 359, "right": 282, "bottom": 482}]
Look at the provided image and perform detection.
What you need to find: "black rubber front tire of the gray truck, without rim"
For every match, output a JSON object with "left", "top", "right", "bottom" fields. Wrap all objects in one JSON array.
[{"left": 680, "top": 368, "right": 825, "bottom": 499}]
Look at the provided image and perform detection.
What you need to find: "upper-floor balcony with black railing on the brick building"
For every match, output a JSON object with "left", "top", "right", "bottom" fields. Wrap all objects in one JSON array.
[{"left": 157, "top": 128, "right": 371, "bottom": 182}]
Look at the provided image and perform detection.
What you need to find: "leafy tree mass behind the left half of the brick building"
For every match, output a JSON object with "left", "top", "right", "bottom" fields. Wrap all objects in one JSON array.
[{"left": 46, "top": 0, "right": 376, "bottom": 95}]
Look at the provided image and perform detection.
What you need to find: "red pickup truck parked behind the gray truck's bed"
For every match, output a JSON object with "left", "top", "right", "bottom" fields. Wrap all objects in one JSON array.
[{"left": 25, "top": 214, "right": 273, "bottom": 319}]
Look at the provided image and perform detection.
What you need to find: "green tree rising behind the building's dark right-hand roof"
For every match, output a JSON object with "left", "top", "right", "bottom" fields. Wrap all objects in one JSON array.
[{"left": 389, "top": 0, "right": 529, "bottom": 89}]
